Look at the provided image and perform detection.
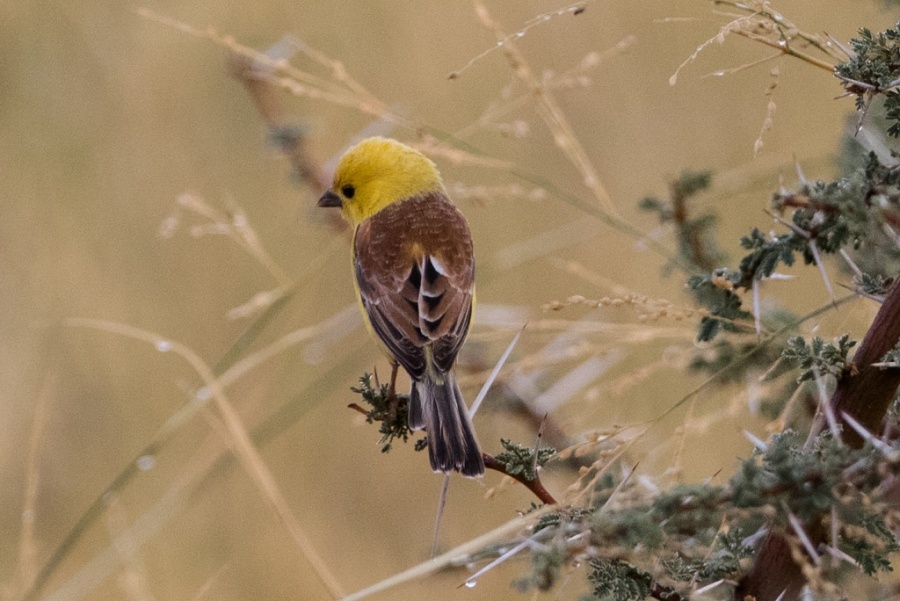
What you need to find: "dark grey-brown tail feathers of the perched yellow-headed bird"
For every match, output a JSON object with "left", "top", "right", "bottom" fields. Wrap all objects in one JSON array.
[{"left": 409, "top": 372, "right": 484, "bottom": 478}]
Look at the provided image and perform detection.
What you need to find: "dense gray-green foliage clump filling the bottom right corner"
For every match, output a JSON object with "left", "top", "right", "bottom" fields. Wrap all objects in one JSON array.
[{"left": 517, "top": 431, "right": 900, "bottom": 601}]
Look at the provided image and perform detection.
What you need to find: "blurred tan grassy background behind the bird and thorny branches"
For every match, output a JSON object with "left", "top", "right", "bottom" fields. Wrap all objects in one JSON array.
[{"left": 0, "top": 0, "right": 896, "bottom": 599}]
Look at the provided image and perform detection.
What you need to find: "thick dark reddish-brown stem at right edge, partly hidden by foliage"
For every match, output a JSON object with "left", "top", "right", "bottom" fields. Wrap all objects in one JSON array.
[{"left": 734, "top": 281, "right": 900, "bottom": 601}]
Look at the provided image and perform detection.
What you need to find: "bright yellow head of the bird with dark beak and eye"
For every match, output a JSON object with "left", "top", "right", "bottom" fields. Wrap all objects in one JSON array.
[{"left": 319, "top": 137, "right": 444, "bottom": 226}]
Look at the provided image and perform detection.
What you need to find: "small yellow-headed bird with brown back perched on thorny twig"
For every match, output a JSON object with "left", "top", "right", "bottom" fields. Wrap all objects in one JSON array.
[{"left": 317, "top": 137, "right": 484, "bottom": 478}]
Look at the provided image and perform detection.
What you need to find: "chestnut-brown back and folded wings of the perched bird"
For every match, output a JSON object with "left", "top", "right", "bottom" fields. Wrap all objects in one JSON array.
[{"left": 354, "top": 194, "right": 475, "bottom": 379}]
